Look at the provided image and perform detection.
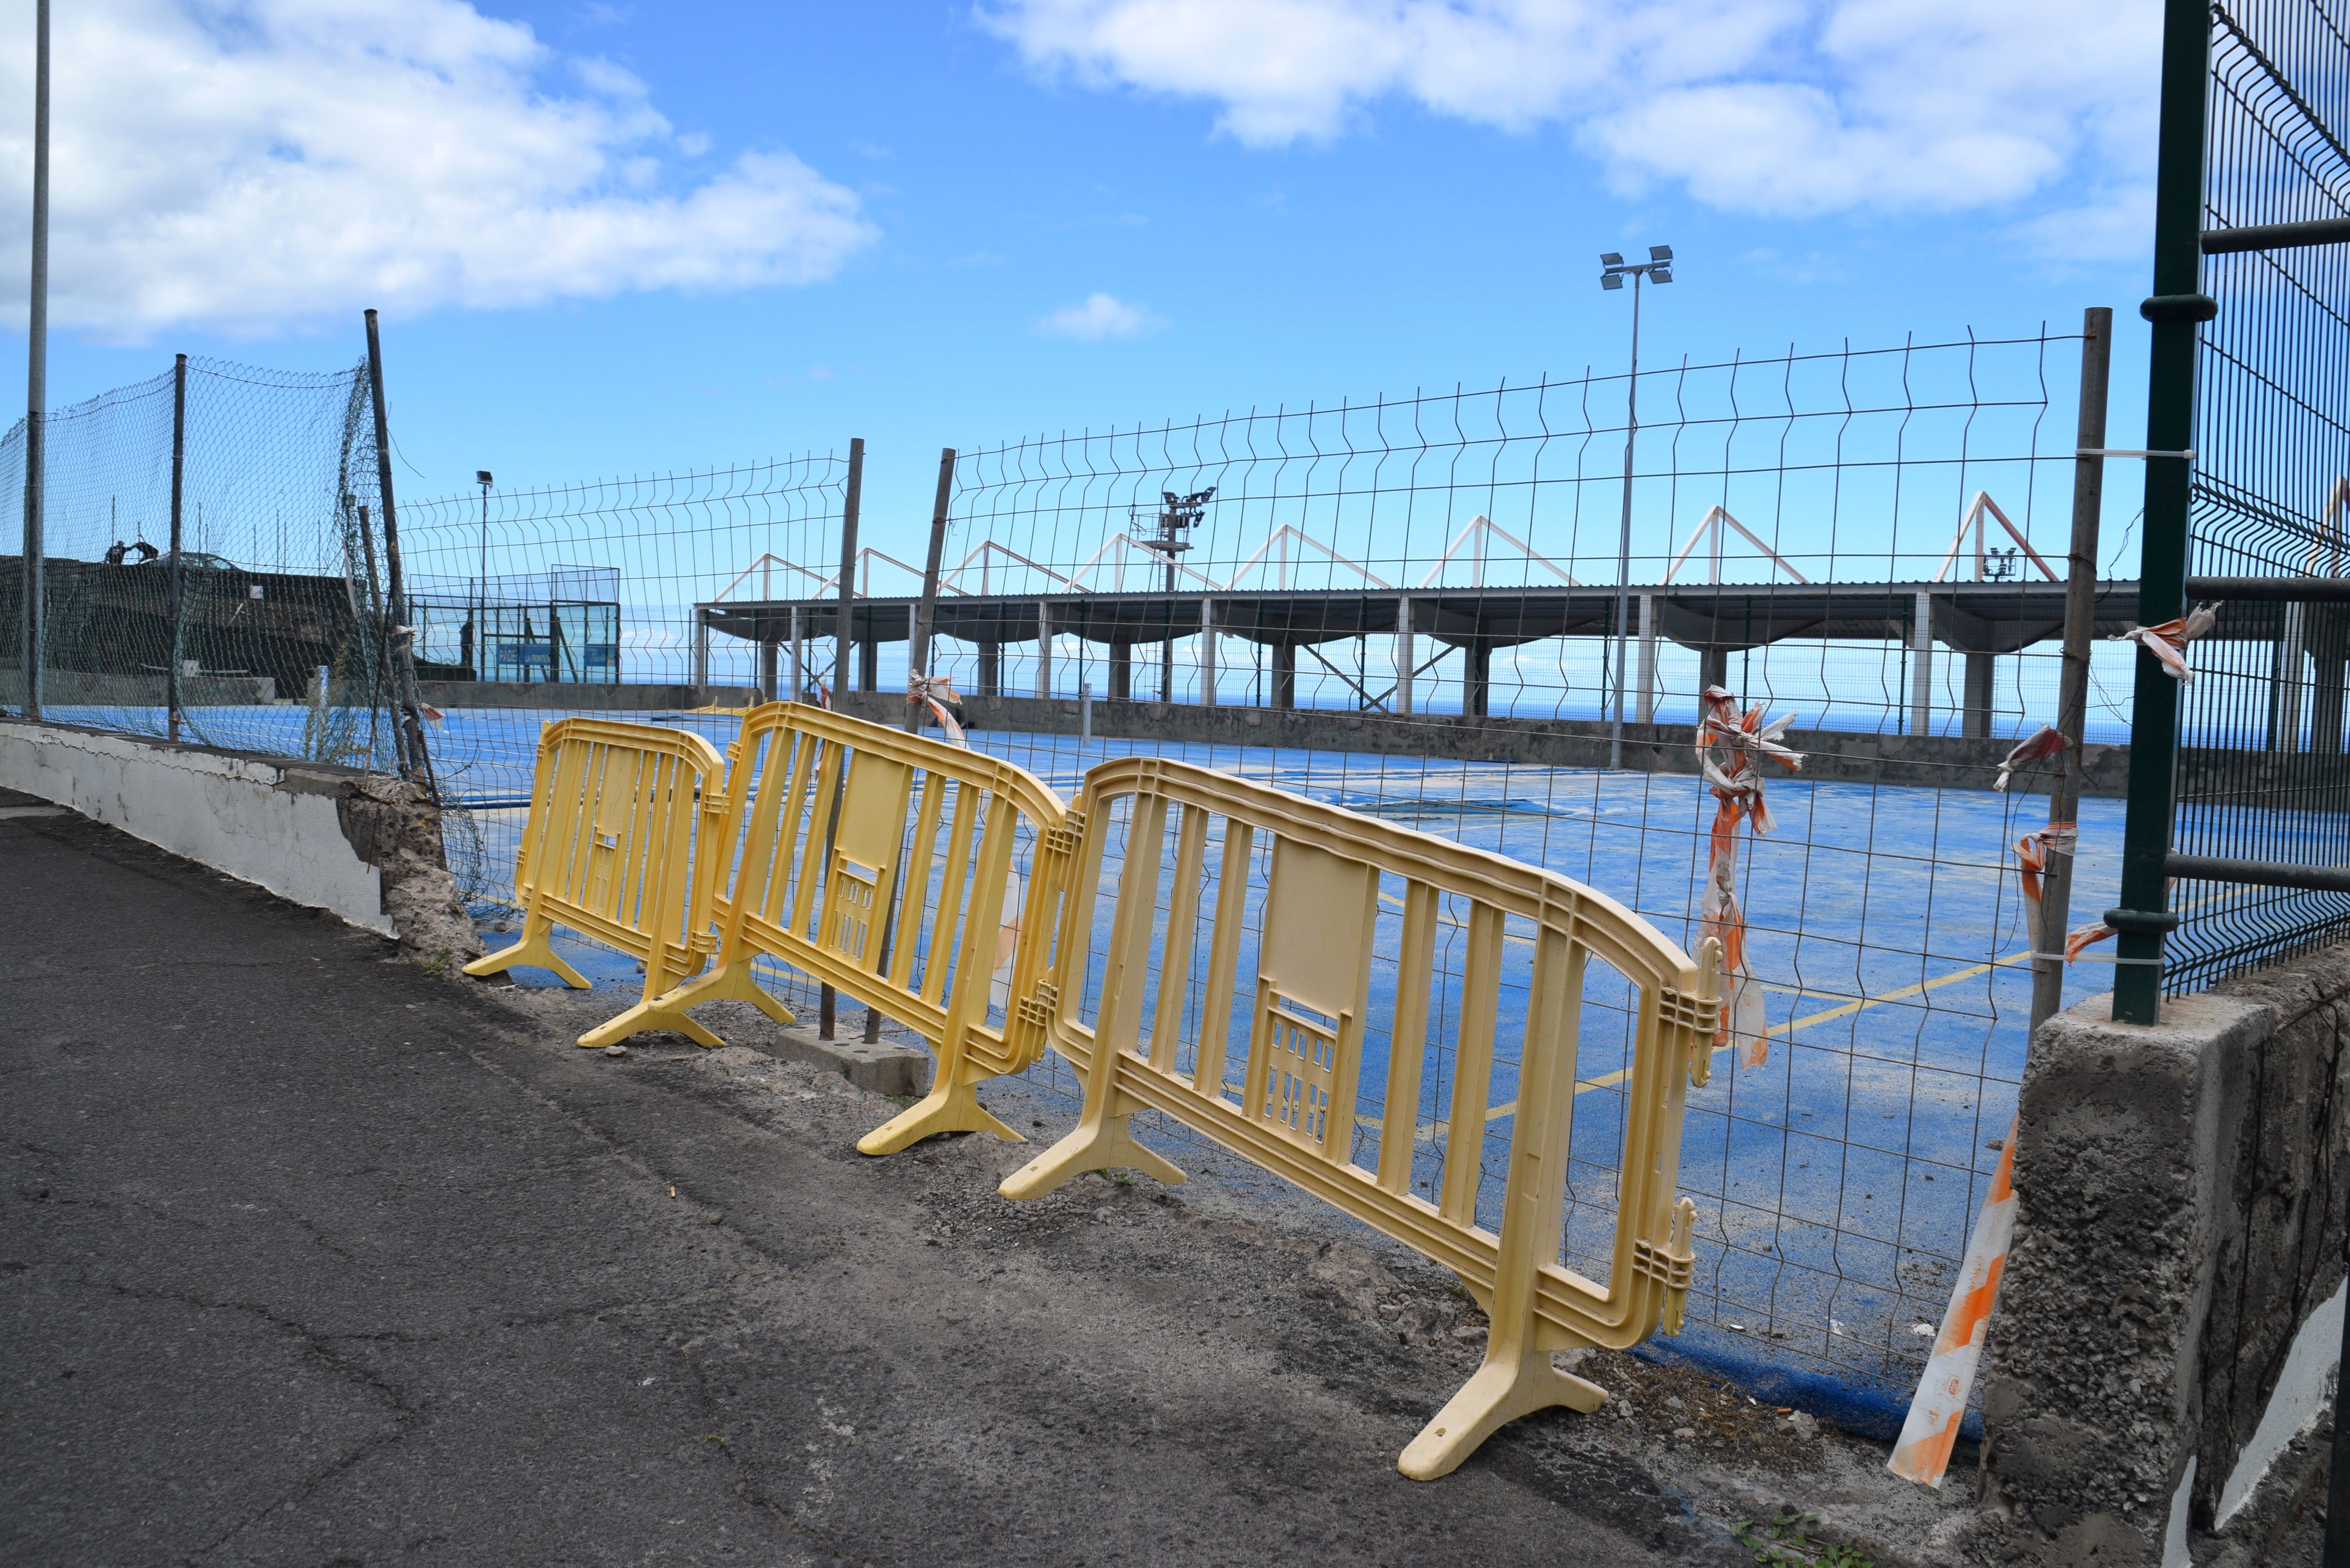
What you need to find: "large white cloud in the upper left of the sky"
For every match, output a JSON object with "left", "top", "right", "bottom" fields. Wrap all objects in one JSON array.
[{"left": 0, "top": 0, "right": 877, "bottom": 339}]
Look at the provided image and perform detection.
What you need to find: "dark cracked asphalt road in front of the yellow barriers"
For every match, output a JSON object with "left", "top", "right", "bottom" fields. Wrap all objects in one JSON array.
[{"left": 0, "top": 792, "right": 1744, "bottom": 1568}]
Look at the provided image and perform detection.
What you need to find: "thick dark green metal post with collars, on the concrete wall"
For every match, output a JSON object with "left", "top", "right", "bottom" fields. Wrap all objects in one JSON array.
[{"left": 2105, "top": 0, "right": 2218, "bottom": 1023}]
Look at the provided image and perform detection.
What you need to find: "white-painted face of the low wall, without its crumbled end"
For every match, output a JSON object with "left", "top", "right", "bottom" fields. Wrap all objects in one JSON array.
[{"left": 0, "top": 722, "right": 393, "bottom": 936}]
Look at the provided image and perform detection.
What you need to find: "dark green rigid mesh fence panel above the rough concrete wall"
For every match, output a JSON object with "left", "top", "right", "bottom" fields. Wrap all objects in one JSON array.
[{"left": 2138, "top": 0, "right": 2350, "bottom": 992}]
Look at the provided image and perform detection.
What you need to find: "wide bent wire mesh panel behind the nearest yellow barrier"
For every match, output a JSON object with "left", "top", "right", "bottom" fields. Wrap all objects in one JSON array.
[{"left": 615, "top": 322, "right": 2134, "bottom": 1422}]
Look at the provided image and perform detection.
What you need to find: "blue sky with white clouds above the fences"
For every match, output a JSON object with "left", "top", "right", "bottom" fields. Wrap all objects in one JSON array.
[{"left": 0, "top": 0, "right": 2157, "bottom": 555}]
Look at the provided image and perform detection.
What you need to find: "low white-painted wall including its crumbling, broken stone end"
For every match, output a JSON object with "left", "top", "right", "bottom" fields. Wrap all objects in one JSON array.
[{"left": 0, "top": 717, "right": 479, "bottom": 957}]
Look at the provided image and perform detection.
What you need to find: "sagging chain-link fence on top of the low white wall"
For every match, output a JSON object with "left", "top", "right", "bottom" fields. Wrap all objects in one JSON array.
[{"left": 0, "top": 360, "right": 393, "bottom": 769}]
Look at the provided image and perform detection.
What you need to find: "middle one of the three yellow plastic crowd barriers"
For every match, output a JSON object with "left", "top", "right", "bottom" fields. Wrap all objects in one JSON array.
[{"left": 660, "top": 703, "right": 1074, "bottom": 1154}]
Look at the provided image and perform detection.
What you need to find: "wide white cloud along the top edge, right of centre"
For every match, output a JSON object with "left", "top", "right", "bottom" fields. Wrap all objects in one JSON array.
[{"left": 982, "top": 0, "right": 2160, "bottom": 236}]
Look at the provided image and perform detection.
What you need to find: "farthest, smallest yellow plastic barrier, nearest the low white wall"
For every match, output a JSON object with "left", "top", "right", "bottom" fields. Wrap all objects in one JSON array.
[{"left": 465, "top": 719, "right": 747, "bottom": 1046}]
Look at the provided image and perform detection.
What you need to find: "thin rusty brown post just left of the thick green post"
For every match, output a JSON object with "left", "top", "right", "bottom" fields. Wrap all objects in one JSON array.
[{"left": 2026, "top": 306, "right": 2113, "bottom": 1048}]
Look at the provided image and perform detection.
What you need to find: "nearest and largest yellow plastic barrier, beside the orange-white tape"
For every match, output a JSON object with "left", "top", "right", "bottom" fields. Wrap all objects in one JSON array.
[{"left": 1004, "top": 757, "right": 1720, "bottom": 1481}]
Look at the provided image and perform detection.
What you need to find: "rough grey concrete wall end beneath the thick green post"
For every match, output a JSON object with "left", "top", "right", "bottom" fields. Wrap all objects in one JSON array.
[{"left": 1984, "top": 948, "right": 2350, "bottom": 1566}]
